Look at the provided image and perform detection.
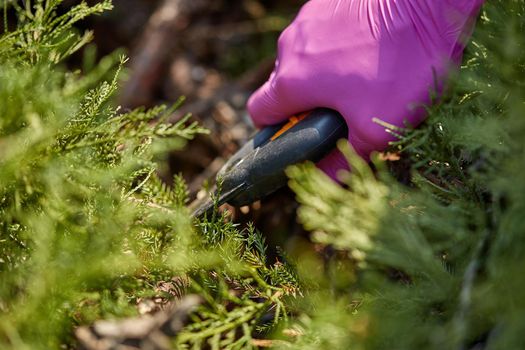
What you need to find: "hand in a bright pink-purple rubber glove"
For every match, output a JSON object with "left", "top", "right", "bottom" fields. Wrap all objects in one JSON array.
[{"left": 248, "top": 0, "right": 483, "bottom": 179}]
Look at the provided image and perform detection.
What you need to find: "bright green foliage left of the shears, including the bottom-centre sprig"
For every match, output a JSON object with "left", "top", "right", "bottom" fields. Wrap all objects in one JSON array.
[{"left": 0, "top": 0, "right": 297, "bottom": 349}]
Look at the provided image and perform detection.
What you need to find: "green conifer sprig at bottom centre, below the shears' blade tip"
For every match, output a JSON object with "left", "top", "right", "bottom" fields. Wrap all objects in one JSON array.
[{"left": 180, "top": 209, "right": 300, "bottom": 349}]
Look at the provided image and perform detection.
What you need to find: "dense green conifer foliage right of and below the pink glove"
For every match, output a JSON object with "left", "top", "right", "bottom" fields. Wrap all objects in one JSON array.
[{"left": 289, "top": 1, "right": 525, "bottom": 349}]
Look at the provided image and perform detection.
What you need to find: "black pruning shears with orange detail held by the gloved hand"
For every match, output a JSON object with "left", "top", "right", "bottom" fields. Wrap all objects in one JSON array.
[{"left": 192, "top": 108, "right": 348, "bottom": 217}]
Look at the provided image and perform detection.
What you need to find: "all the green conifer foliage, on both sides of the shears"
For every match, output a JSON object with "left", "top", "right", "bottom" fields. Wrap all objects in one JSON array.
[{"left": 0, "top": 0, "right": 525, "bottom": 349}]
